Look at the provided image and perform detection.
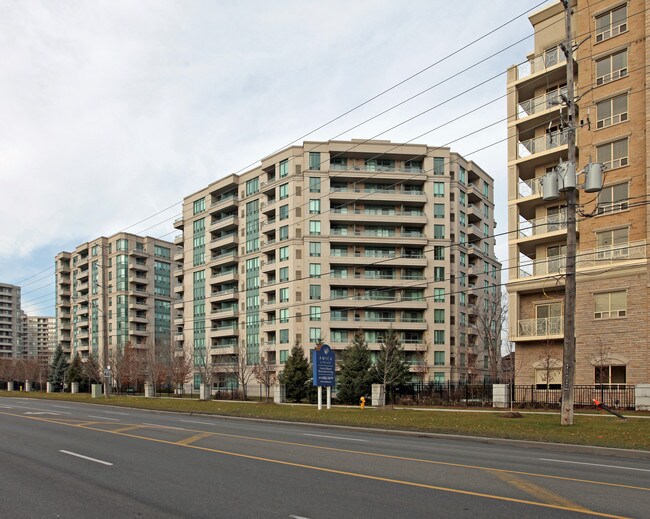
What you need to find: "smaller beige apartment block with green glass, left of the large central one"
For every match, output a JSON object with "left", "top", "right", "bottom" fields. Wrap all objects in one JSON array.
[{"left": 55, "top": 233, "right": 172, "bottom": 359}]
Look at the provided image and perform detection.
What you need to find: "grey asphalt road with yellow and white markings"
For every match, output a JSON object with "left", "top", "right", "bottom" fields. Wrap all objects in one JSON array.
[{"left": 0, "top": 398, "right": 650, "bottom": 519}]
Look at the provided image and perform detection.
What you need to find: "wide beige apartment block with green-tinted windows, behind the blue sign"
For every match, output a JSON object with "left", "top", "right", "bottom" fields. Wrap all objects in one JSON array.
[{"left": 174, "top": 140, "right": 500, "bottom": 383}]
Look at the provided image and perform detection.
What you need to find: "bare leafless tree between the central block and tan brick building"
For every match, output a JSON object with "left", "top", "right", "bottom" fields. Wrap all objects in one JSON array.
[{"left": 472, "top": 294, "right": 508, "bottom": 382}]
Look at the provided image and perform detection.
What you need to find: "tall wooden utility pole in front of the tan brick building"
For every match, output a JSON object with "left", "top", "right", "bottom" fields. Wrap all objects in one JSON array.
[{"left": 560, "top": 0, "right": 577, "bottom": 425}]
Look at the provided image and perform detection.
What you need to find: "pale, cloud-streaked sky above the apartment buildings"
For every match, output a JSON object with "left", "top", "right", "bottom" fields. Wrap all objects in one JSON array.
[{"left": 0, "top": 0, "right": 549, "bottom": 315}]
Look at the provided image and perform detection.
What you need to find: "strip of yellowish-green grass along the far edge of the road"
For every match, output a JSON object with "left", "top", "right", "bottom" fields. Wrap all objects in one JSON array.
[{"left": 0, "top": 391, "right": 650, "bottom": 451}]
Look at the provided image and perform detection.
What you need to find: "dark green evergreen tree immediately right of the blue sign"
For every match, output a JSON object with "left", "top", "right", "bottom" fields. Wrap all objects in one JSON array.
[{"left": 336, "top": 330, "right": 372, "bottom": 405}]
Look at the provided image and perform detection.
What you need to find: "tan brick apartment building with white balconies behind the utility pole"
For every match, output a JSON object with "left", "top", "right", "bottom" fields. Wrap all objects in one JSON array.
[{"left": 508, "top": 0, "right": 650, "bottom": 386}]
